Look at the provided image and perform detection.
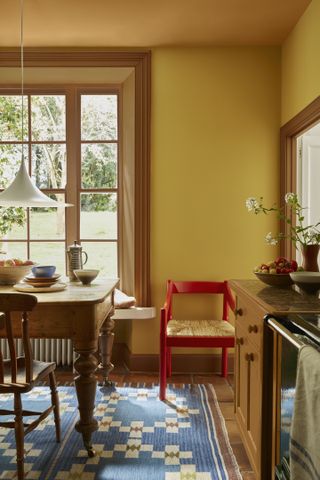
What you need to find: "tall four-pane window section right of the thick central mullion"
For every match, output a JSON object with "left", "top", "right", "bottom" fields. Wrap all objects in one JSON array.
[{"left": 79, "top": 93, "right": 120, "bottom": 277}]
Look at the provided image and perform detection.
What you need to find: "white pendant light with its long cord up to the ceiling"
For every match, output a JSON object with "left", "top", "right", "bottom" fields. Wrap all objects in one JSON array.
[{"left": 0, "top": 0, "right": 73, "bottom": 208}]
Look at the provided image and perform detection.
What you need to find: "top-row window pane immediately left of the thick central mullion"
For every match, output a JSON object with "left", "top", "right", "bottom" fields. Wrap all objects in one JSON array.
[{"left": 31, "top": 95, "right": 66, "bottom": 141}]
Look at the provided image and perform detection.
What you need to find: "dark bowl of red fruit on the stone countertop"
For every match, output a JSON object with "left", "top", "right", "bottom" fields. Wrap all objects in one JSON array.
[{"left": 254, "top": 257, "right": 298, "bottom": 287}]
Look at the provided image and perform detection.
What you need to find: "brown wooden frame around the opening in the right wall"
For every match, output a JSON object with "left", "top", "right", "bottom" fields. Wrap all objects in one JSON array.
[{"left": 280, "top": 96, "right": 320, "bottom": 258}]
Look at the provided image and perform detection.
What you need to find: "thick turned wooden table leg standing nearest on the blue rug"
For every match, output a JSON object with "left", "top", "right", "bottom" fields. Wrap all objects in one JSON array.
[{"left": 74, "top": 346, "right": 98, "bottom": 457}]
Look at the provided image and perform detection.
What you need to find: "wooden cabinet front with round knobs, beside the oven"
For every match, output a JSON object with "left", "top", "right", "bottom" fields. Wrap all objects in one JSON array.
[{"left": 235, "top": 295, "right": 264, "bottom": 478}]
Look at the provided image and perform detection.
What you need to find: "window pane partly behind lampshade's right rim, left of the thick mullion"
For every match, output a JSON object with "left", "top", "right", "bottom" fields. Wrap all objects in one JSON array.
[{"left": 30, "top": 194, "right": 65, "bottom": 240}]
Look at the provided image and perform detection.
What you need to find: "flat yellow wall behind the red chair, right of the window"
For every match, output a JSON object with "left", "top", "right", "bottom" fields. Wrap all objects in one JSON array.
[{"left": 132, "top": 48, "right": 280, "bottom": 353}]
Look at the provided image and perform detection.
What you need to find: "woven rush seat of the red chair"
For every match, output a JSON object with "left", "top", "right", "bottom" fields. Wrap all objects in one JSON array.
[{"left": 167, "top": 319, "right": 235, "bottom": 337}]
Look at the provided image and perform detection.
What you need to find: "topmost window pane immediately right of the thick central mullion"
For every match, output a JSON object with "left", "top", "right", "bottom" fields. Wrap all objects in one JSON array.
[{"left": 81, "top": 95, "right": 118, "bottom": 140}]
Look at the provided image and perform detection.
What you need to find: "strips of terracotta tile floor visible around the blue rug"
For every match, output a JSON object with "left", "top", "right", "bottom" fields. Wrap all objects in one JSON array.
[{"left": 56, "top": 368, "right": 256, "bottom": 480}]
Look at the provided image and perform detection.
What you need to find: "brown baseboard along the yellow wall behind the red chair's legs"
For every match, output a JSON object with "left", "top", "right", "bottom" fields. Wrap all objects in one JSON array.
[{"left": 112, "top": 343, "right": 234, "bottom": 374}]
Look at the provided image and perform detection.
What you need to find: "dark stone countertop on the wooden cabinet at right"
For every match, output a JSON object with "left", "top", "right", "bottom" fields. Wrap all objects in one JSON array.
[{"left": 229, "top": 280, "right": 320, "bottom": 314}]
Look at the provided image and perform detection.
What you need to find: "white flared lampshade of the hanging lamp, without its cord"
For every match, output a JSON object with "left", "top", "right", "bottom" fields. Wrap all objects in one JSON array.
[{"left": 0, "top": 157, "right": 72, "bottom": 208}]
